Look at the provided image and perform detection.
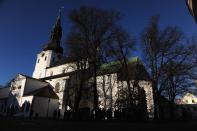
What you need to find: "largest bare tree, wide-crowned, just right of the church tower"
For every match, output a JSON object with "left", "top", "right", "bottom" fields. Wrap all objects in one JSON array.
[{"left": 65, "top": 6, "right": 121, "bottom": 109}]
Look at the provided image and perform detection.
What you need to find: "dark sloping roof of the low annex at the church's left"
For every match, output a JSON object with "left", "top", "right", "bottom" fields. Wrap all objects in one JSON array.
[{"left": 23, "top": 85, "right": 59, "bottom": 99}]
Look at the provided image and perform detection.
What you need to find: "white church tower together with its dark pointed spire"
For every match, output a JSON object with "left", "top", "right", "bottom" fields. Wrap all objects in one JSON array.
[{"left": 32, "top": 10, "right": 63, "bottom": 79}]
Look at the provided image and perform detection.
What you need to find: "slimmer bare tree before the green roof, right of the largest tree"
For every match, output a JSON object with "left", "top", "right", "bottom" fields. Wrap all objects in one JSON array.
[{"left": 106, "top": 27, "right": 135, "bottom": 105}]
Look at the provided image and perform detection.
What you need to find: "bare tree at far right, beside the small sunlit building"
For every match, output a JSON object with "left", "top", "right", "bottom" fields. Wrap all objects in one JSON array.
[{"left": 161, "top": 44, "right": 197, "bottom": 119}]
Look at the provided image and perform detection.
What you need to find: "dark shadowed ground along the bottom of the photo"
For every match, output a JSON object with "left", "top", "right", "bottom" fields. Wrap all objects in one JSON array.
[{"left": 0, "top": 118, "right": 197, "bottom": 131}]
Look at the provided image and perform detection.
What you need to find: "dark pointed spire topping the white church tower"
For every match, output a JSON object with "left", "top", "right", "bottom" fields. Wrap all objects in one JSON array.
[{"left": 43, "top": 8, "right": 63, "bottom": 54}]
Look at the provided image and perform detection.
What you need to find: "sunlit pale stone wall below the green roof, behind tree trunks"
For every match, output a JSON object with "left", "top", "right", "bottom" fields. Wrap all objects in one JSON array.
[{"left": 97, "top": 73, "right": 154, "bottom": 118}]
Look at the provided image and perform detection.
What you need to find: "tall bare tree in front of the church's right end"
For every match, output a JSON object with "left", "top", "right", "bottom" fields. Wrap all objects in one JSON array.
[{"left": 141, "top": 16, "right": 189, "bottom": 119}]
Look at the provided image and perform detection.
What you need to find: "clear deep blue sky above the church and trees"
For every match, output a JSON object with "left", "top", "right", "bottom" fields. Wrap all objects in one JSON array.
[{"left": 0, "top": 0, "right": 197, "bottom": 85}]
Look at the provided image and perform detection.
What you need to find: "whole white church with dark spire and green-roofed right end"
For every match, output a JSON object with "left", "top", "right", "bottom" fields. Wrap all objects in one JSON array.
[{"left": 0, "top": 13, "right": 154, "bottom": 118}]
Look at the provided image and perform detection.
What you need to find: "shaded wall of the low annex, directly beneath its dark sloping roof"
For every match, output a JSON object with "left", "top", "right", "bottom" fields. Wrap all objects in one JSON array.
[{"left": 32, "top": 96, "right": 59, "bottom": 117}]
